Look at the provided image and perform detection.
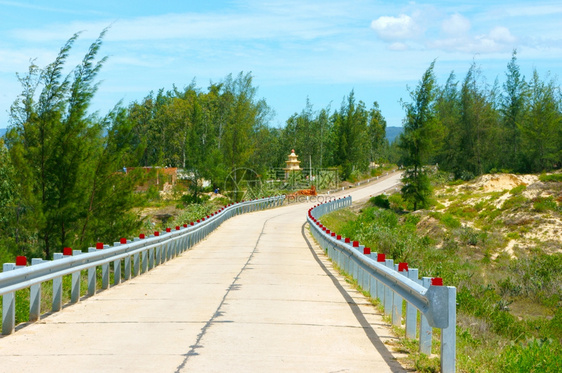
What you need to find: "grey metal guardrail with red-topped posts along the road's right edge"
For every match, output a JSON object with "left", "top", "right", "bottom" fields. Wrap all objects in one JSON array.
[{"left": 307, "top": 196, "right": 456, "bottom": 373}]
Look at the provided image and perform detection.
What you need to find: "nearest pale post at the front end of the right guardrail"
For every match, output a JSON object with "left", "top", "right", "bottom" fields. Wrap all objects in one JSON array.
[{"left": 441, "top": 286, "right": 457, "bottom": 373}]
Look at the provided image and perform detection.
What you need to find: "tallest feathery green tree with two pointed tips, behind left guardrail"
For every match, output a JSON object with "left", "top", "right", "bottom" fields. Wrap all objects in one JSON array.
[{"left": 7, "top": 31, "right": 105, "bottom": 257}]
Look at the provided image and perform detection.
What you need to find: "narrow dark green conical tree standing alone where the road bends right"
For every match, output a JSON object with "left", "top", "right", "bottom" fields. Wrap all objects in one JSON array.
[{"left": 399, "top": 61, "right": 437, "bottom": 210}]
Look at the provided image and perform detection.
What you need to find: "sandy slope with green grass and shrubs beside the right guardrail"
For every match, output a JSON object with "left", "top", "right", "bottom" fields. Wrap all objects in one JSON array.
[{"left": 322, "top": 169, "right": 562, "bottom": 372}]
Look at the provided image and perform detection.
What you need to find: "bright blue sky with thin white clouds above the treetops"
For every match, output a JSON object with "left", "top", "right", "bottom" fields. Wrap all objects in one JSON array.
[{"left": 0, "top": 0, "right": 562, "bottom": 128}]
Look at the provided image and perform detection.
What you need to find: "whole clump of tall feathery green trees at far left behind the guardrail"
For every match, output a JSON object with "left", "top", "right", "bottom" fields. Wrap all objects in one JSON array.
[{"left": 6, "top": 31, "right": 140, "bottom": 257}]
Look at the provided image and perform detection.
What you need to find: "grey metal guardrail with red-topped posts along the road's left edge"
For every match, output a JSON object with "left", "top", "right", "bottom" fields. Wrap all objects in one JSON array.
[{"left": 0, "top": 196, "right": 285, "bottom": 335}]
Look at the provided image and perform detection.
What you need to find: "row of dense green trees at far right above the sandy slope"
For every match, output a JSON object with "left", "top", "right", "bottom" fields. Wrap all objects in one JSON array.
[{"left": 426, "top": 51, "right": 562, "bottom": 177}]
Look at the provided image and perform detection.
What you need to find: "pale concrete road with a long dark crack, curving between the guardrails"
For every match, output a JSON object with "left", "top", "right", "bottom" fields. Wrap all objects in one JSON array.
[{"left": 0, "top": 174, "right": 404, "bottom": 372}]
